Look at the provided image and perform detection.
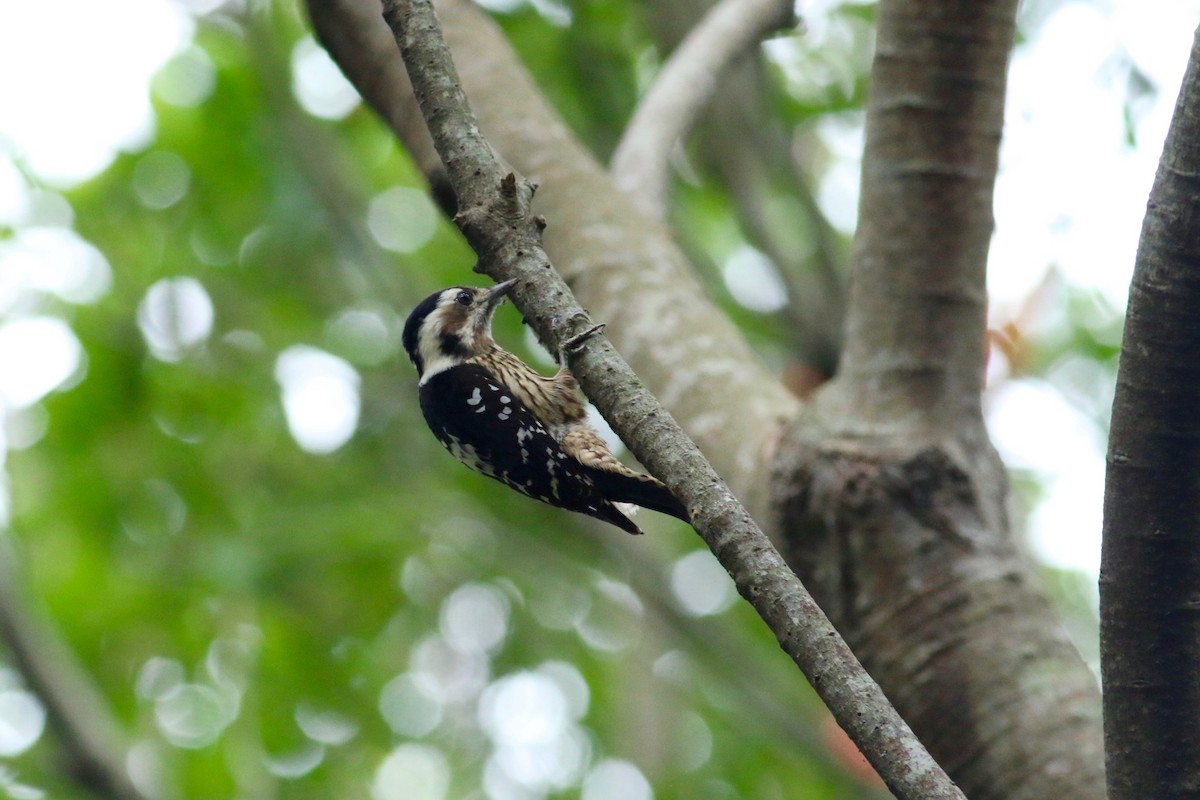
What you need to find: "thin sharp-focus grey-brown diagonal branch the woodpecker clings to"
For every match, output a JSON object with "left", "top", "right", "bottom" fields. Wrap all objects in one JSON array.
[{"left": 384, "top": 0, "right": 962, "bottom": 800}]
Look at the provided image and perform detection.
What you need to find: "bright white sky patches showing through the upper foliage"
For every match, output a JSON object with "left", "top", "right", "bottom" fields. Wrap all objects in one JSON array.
[{"left": 0, "top": 0, "right": 1200, "bottom": 594}]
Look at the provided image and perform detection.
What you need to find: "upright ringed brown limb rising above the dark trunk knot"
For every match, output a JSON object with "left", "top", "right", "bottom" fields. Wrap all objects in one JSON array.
[{"left": 840, "top": 0, "right": 1016, "bottom": 431}]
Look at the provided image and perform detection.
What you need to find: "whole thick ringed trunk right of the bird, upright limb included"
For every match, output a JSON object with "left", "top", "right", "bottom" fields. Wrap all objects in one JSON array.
[{"left": 776, "top": 0, "right": 1104, "bottom": 800}]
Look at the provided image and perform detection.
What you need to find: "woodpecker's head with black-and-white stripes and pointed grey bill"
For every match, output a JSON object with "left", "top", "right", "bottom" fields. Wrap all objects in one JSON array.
[{"left": 403, "top": 278, "right": 517, "bottom": 381}]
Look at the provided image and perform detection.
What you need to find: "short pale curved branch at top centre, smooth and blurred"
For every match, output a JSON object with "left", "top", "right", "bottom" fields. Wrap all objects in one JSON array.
[{"left": 611, "top": 0, "right": 796, "bottom": 218}]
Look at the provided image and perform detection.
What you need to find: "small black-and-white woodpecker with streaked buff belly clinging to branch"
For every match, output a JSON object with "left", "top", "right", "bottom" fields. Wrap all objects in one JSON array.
[{"left": 403, "top": 279, "right": 690, "bottom": 534}]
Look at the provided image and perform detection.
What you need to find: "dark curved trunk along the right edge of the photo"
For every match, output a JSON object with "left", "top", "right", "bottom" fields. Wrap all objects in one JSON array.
[{"left": 1100, "top": 20, "right": 1200, "bottom": 800}]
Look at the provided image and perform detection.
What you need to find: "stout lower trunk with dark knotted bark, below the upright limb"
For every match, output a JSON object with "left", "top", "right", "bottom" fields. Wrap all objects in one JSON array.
[{"left": 781, "top": 432, "right": 1103, "bottom": 800}]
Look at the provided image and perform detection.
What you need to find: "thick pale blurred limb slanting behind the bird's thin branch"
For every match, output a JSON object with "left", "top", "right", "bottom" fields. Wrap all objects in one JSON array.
[{"left": 307, "top": 0, "right": 799, "bottom": 521}]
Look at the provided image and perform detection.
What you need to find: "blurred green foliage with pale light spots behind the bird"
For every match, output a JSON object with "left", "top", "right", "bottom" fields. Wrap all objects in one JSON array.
[{"left": 0, "top": 0, "right": 1114, "bottom": 800}]
